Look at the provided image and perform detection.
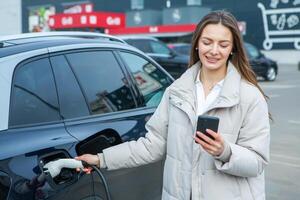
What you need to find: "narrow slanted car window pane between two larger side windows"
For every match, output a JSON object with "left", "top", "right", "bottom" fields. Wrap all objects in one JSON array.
[{"left": 50, "top": 55, "right": 89, "bottom": 119}]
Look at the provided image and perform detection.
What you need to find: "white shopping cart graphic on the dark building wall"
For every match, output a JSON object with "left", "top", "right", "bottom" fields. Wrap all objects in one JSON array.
[{"left": 257, "top": 3, "right": 300, "bottom": 50}]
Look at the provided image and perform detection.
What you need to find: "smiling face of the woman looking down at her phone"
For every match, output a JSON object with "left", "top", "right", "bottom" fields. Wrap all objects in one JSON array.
[{"left": 198, "top": 23, "right": 233, "bottom": 70}]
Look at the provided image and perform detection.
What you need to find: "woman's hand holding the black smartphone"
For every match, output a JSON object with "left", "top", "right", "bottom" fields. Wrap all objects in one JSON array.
[{"left": 194, "top": 129, "right": 224, "bottom": 156}]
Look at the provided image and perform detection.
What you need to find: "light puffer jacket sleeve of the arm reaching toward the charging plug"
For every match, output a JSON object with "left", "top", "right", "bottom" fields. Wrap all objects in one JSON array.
[{"left": 102, "top": 88, "right": 169, "bottom": 170}]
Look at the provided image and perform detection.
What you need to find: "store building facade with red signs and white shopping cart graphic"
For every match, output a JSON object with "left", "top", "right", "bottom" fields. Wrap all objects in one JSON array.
[{"left": 22, "top": 0, "right": 300, "bottom": 50}]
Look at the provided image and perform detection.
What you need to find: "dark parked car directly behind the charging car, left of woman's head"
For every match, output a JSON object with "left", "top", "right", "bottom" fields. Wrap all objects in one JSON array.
[{"left": 121, "top": 36, "right": 189, "bottom": 79}]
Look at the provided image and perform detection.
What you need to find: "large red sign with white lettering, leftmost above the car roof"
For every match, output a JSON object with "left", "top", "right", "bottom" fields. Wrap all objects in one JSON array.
[{"left": 48, "top": 12, "right": 125, "bottom": 29}]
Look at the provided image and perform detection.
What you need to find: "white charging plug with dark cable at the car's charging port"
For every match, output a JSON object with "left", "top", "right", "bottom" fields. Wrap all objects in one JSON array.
[{"left": 43, "top": 158, "right": 111, "bottom": 200}]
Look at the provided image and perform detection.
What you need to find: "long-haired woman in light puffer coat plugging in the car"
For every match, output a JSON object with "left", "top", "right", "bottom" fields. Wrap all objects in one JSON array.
[{"left": 77, "top": 11, "right": 270, "bottom": 200}]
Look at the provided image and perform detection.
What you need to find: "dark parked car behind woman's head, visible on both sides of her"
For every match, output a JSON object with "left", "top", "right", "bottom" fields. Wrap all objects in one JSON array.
[{"left": 168, "top": 42, "right": 278, "bottom": 81}]
